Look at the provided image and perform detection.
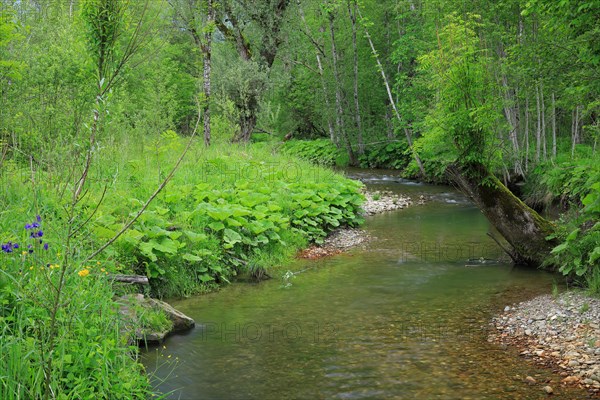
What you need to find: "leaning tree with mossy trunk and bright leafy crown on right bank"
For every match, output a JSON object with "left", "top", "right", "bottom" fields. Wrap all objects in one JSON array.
[{"left": 420, "top": 14, "right": 554, "bottom": 266}]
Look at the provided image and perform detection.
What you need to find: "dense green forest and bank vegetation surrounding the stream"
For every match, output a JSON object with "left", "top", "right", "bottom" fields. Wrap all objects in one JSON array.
[{"left": 0, "top": 0, "right": 600, "bottom": 399}]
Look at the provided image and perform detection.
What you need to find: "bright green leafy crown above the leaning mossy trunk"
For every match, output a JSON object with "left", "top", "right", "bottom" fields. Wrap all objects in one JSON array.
[{"left": 419, "top": 14, "right": 500, "bottom": 170}]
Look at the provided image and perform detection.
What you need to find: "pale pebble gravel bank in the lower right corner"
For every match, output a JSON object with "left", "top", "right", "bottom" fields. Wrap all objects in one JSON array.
[{"left": 489, "top": 292, "right": 600, "bottom": 397}]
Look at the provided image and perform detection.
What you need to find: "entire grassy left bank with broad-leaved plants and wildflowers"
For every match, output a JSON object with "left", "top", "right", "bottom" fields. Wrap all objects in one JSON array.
[{"left": 0, "top": 131, "right": 363, "bottom": 399}]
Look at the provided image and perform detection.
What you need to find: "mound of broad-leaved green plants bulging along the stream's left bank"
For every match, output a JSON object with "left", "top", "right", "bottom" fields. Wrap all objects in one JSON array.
[{"left": 73, "top": 141, "right": 362, "bottom": 297}]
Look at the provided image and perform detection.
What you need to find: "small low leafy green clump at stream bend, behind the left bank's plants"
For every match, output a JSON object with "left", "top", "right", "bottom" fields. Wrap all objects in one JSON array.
[{"left": 282, "top": 139, "right": 347, "bottom": 167}]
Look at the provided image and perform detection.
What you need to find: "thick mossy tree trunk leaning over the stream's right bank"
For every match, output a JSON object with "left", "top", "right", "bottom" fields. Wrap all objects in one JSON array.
[{"left": 446, "top": 164, "right": 557, "bottom": 267}]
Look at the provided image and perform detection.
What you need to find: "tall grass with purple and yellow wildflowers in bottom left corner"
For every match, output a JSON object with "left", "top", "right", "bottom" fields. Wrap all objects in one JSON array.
[{"left": 0, "top": 218, "right": 149, "bottom": 399}]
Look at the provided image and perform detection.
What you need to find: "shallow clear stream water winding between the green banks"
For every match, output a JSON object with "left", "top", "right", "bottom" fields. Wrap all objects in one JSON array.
[{"left": 144, "top": 170, "right": 586, "bottom": 400}]
